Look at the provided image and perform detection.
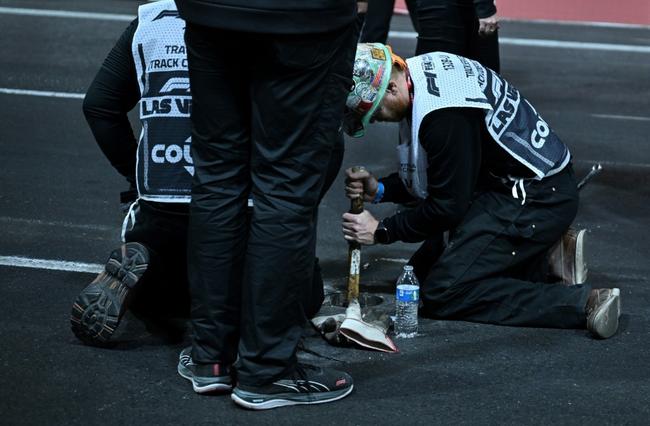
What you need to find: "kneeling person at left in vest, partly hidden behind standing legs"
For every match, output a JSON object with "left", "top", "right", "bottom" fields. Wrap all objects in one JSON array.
[{"left": 71, "top": 0, "right": 334, "bottom": 346}]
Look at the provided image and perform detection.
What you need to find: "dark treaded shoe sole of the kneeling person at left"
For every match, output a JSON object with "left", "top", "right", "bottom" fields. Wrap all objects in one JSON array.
[{"left": 70, "top": 243, "right": 149, "bottom": 346}]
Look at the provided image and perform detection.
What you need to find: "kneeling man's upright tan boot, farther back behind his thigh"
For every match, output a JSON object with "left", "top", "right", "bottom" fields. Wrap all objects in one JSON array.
[{"left": 548, "top": 228, "right": 587, "bottom": 285}]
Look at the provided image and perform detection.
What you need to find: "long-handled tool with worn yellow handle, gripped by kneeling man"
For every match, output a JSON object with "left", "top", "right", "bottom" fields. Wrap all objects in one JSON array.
[{"left": 339, "top": 167, "right": 397, "bottom": 352}]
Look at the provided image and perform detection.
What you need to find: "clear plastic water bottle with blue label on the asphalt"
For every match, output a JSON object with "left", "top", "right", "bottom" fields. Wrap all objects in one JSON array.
[{"left": 395, "top": 265, "right": 420, "bottom": 338}]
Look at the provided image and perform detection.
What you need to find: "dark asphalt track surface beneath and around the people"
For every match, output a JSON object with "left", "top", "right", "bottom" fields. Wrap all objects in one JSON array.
[{"left": 0, "top": 0, "right": 650, "bottom": 425}]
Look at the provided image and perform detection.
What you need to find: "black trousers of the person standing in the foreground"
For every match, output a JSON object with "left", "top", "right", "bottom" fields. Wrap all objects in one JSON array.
[{"left": 185, "top": 23, "right": 357, "bottom": 386}]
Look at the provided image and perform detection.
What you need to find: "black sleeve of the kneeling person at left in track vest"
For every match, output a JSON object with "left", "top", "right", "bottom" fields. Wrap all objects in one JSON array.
[{"left": 83, "top": 19, "right": 140, "bottom": 185}]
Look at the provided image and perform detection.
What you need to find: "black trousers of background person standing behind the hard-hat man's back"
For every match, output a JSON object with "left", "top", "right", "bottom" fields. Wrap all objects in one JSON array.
[{"left": 415, "top": 0, "right": 500, "bottom": 73}]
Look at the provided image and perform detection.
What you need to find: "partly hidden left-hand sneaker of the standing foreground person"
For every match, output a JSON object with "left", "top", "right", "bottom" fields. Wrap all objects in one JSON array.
[{"left": 177, "top": 346, "right": 232, "bottom": 393}]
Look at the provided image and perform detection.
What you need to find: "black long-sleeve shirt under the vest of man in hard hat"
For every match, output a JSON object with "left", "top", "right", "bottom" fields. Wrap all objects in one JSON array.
[{"left": 380, "top": 108, "right": 533, "bottom": 242}]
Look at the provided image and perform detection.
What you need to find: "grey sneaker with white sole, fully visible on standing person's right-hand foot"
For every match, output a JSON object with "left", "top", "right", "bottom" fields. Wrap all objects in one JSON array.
[{"left": 231, "top": 364, "right": 354, "bottom": 410}]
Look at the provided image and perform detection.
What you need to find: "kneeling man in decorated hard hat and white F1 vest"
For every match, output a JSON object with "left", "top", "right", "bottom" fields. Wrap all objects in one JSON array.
[{"left": 343, "top": 43, "right": 620, "bottom": 338}]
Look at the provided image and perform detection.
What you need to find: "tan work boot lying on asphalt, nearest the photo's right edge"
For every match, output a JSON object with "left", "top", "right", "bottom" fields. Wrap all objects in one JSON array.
[{"left": 586, "top": 288, "right": 621, "bottom": 339}]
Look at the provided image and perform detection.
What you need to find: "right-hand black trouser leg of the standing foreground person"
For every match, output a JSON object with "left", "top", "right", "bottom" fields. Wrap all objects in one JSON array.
[{"left": 238, "top": 25, "right": 356, "bottom": 387}]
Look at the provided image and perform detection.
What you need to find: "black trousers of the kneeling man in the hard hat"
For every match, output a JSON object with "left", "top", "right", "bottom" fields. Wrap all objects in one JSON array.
[{"left": 411, "top": 165, "right": 591, "bottom": 328}]
